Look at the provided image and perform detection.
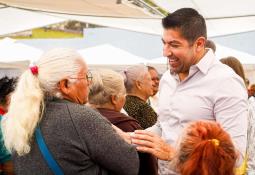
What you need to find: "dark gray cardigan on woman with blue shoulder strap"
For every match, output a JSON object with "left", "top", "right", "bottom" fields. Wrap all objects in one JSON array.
[{"left": 13, "top": 100, "right": 139, "bottom": 175}]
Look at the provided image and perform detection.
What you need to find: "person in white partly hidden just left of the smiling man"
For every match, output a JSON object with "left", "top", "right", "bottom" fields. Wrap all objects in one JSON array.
[{"left": 147, "top": 66, "right": 159, "bottom": 112}]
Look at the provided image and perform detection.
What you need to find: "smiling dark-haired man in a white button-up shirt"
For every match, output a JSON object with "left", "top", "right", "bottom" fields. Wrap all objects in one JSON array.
[{"left": 132, "top": 8, "right": 248, "bottom": 175}]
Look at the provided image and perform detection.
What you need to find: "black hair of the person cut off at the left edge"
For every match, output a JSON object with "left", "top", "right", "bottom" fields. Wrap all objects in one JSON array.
[{"left": 0, "top": 77, "right": 17, "bottom": 104}]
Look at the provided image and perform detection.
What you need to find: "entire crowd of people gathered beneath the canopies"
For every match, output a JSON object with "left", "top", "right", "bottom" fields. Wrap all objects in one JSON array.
[{"left": 0, "top": 8, "right": 255, "bottom": 175}]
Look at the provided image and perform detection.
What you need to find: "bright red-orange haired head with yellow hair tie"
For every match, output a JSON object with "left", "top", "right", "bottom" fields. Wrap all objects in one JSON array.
[{"left": 177, "top": 121, "right": 237, "bottom": 175}]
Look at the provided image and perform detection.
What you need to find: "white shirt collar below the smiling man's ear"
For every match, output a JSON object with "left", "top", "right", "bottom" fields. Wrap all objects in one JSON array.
[{"left": 195, "top": 49, "right": 216, "bottom": 74}]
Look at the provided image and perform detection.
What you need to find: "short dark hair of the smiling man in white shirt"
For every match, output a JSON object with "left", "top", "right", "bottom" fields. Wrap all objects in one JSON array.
[{"left": 162, "top": 8, "right": 207, "bottom": 44}]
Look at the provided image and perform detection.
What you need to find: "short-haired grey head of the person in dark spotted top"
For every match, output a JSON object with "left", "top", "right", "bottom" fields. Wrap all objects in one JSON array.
[{"left": 124, "top": 65, "right": 153, "bottom": 101}]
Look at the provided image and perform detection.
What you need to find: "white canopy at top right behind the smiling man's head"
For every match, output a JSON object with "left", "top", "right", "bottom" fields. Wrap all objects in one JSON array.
[{"left": 150, "top": 0, "right": 255, "bottom": 37}]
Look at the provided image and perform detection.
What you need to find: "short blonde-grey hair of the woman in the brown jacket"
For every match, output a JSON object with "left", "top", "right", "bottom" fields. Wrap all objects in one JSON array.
[{"left": 89, "top": 69, "right": 126, "bottom": 106}]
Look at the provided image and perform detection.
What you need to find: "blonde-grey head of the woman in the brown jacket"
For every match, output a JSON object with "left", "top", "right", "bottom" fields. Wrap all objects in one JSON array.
[{"left": 89, "top": 69, "right": 126, "bottom": 112}]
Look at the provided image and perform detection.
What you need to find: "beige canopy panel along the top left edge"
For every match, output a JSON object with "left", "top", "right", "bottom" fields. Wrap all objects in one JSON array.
[{"left": 1, "top": 0, "right": 155, "bottom": 18}]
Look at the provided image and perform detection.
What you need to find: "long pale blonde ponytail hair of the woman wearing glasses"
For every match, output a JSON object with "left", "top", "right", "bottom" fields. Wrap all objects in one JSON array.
[{"left": 2, "top": 48, "right": 83, "bottom": 155}]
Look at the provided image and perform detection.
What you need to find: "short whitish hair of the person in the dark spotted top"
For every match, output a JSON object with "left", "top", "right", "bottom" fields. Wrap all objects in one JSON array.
[{"left": 123, "top": 65, "right": 148, "bottom": 93}]
